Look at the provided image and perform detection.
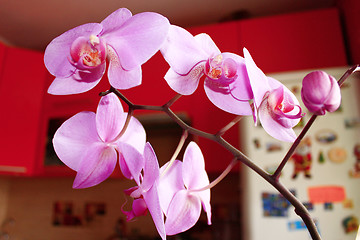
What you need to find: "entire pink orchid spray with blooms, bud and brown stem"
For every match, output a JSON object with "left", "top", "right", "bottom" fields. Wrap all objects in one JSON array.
[{"left": 44, "top": 8, "right": 358, "bottom": 240}]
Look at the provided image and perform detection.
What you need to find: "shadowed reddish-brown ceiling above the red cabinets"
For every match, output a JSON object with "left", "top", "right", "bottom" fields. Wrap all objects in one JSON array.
[{"left": 0, "top": 0, "right": 336, "bottom": 50}]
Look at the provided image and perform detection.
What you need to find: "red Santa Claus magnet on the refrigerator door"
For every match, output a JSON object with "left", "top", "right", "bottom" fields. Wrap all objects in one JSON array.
[{"left": 291, "top": 137, "right": 312, "bottom": 179}]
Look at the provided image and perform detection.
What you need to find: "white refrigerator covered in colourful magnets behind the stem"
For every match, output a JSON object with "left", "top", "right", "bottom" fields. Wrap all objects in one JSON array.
[{"left": 240, "top": 67, "right": 360, "bottom": 240}]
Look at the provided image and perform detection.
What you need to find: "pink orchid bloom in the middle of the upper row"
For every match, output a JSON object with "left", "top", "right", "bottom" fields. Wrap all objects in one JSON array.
[{"left": 160, "top": 25, "right": 252, "bottom": 115}]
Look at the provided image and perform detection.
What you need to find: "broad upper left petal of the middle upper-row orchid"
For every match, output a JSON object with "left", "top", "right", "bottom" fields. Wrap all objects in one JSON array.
[{"left": 160, "top": 25, "right": 210, "bottom": 75}]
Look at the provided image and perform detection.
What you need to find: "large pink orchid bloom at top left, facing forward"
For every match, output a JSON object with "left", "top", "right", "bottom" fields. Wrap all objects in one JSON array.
[{"left": 44, "top": 8, "right": 170, "bottom": 95}]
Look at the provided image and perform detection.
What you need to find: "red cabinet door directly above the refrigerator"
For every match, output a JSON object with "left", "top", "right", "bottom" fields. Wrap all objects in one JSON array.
[{"left": 239, "top": 8, "right": 347, "bottom": 73}]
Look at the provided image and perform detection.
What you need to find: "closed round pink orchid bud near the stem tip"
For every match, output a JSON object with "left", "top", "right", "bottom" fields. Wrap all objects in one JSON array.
[{"left": 301, "top": 71, "right": 341, "bottom": 115}]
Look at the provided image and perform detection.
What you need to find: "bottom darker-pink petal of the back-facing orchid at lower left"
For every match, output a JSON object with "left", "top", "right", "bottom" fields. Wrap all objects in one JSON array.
[{"left": 73, "top": 144, "right": 117, "bottom": 188}]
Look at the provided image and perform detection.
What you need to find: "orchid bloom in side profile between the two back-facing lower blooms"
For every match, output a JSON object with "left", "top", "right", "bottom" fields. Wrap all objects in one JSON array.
[{"left": 122, "top": 143, "right": 166, "bottom": 239}]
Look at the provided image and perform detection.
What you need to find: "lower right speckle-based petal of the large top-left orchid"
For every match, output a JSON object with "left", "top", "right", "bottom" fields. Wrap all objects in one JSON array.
[{"left": 108, "top": 46, "right": 142, "bottom": 89}]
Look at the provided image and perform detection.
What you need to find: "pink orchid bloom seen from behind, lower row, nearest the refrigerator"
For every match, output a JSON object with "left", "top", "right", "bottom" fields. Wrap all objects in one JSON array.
[{"left": 159, "top": 142, "right": 211, "bottom": 235}]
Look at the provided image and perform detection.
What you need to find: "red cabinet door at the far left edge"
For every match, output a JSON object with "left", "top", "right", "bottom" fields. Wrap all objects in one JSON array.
[{"left": 0, "top": 47, "right": 45, "bottom": 176}]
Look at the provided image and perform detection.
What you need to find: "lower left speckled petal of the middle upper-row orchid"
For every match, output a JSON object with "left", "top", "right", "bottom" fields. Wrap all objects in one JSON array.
[{"left": 164, "top": 63, "right": 204, "bottom": 95}]
